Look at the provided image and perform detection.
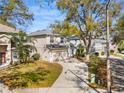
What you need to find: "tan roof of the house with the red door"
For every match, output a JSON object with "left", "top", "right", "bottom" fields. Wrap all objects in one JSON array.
[{"left": 0, "top": 24, "right": 19, "bottom": 33}]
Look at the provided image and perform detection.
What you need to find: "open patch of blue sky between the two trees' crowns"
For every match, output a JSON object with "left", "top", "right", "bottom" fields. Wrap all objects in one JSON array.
[{"left": 24, "top": 0, "right": 65, "bottom": 32}]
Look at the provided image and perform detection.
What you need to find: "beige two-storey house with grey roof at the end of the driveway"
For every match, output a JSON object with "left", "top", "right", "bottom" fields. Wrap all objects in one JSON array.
[{"left": 29, "top": 30, "right": 68, "bottom": 62}]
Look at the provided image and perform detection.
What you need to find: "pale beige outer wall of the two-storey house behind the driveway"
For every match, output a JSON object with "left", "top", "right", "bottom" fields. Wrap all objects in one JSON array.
[{"left": 32, "top": 36, "right": 67, "bottom": 62}]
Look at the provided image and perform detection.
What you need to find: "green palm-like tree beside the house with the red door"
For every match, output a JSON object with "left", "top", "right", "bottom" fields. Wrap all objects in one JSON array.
[{"left": 11, "top": 31, "right": 36, "bottom": 63}]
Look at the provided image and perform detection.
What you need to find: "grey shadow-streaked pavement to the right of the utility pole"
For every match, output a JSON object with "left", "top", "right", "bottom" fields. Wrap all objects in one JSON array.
[{"left": 110, "top": 58, "right": 124, "bottom": 93}]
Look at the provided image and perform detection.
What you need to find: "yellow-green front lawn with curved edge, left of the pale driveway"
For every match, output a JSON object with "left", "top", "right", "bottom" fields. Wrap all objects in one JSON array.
[{"left": 0, "top": 61, "right": 62, "bottom": 89}]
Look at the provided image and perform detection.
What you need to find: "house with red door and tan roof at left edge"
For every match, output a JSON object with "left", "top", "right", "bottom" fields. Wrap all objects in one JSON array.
[{"left": 0, "top": 24, "right": 18, "bottom": 67}]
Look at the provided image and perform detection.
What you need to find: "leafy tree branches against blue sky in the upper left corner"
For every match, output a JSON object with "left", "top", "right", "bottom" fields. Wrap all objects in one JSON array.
[{"left": 0, "top": 0, "right": 33, "bottom": 27}]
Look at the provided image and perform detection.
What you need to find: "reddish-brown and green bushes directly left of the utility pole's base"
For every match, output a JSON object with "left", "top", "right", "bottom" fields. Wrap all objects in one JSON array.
[{"left": 88, "top": 55, "right": 107, "bottom": 87}]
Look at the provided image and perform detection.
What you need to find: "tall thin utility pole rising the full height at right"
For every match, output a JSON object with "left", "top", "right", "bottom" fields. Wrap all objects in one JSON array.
[{"left": 106, "top": 0, "right": 112, "bottom": 93}]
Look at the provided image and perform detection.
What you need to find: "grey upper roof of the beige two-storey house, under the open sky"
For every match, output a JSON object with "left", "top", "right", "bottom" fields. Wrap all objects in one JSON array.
[{"left": 29, "top": 29, "right": 53, "bottom": 36}]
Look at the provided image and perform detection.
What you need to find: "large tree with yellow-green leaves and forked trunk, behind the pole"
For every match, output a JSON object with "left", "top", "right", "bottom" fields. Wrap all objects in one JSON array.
[{"left": 56, "top": 0, "right": 121, "bottom": 61}]
